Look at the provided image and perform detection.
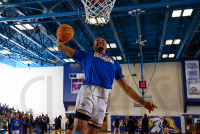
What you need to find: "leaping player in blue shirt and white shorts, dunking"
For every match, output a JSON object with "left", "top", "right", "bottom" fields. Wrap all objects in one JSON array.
[{"left": 57, "top": 37, "right": 157, "bottom": 134}]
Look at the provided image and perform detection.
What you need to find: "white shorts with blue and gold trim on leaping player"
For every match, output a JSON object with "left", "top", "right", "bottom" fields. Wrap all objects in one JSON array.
[{"left": 75, "top": 85, "right": 111, "bottom": 129}]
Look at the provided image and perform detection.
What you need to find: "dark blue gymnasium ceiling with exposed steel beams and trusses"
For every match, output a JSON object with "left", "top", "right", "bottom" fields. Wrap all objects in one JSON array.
[{"left": 0, "top": 0, "right": 200, "bottom": 67}]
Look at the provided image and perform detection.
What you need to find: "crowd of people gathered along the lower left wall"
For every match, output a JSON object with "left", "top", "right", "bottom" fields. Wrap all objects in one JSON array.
[{"left": 0, "top": 103, "right": 62, "bottom": 134}]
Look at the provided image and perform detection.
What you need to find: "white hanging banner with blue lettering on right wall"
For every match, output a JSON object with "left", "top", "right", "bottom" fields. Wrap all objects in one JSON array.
[{"left": 185, "top": 60, "right": 200, "bottom": 99}]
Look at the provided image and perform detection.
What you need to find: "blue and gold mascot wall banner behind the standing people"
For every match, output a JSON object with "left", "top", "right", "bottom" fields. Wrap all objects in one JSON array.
[{"left": 111, "top": 116, "right": 181, "bottom": 133}]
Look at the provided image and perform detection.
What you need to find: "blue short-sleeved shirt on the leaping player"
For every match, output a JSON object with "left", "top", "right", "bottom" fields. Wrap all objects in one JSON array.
[{"left": 72, "top": 50, "right": 124, "bottom": 89}]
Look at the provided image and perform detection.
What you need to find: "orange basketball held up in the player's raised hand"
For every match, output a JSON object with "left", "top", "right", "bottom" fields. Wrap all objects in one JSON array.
[{"left": 56, "top": 24, "right": 74, "bottom": 43}]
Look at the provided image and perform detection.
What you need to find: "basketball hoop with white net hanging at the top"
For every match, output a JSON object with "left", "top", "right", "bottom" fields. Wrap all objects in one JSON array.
[{"left": 81, "top": 0, "right": 116, "bottom": 26}]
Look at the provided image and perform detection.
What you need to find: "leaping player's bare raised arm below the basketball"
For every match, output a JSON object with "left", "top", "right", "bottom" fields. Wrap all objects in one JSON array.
[{"left": 57, "top": 42, "right": 75, "bottom": 57}]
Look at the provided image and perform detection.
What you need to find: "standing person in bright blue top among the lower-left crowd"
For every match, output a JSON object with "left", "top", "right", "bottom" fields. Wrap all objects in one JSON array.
[{"left": 11, "top": 113, "right": 23, "bottom": 134}]
